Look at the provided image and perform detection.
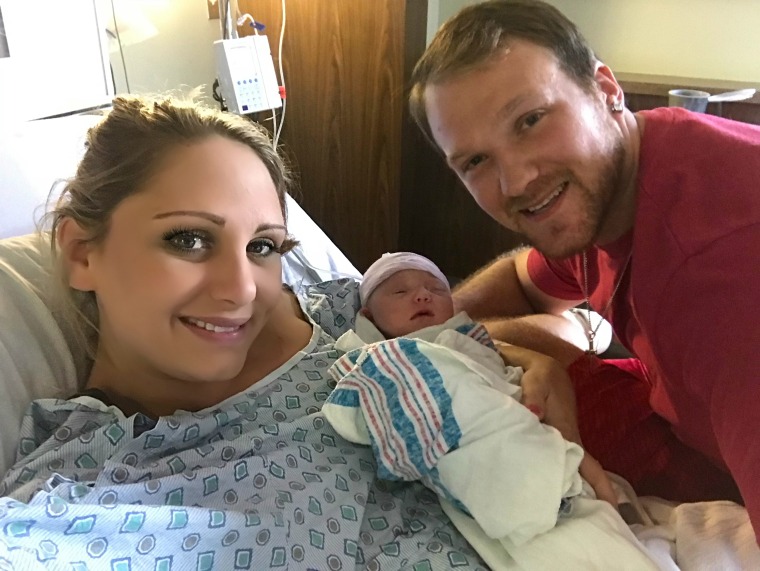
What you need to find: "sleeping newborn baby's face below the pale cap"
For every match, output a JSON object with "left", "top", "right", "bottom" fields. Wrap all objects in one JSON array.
[{"left": 365, "top": 270, "right": 454, "bottom": 338}]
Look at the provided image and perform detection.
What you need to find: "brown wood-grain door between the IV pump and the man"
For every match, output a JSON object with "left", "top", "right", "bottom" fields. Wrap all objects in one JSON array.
[{"left": 239, "top": 0, "right": 427, "bottom": 271}]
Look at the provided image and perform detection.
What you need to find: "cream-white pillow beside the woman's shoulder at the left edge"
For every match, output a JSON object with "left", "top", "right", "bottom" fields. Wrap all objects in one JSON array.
[{"left": 0, "top": 234, "right": 87, "bottom": 474}]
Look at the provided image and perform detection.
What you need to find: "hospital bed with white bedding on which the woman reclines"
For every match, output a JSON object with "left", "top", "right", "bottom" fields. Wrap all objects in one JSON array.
[{"left": 0, "top": 109, "right": 760, "bottom": 570}]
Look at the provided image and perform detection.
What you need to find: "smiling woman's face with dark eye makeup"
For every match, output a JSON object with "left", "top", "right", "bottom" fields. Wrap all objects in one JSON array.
[{"left": 72, "top": 136, "right": 286, "bottom": 382}]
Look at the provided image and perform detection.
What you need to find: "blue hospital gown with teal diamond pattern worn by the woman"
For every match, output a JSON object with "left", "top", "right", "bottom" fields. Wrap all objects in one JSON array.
[{"left": 0, "top": 280, "right": 485, "bottom": 571}]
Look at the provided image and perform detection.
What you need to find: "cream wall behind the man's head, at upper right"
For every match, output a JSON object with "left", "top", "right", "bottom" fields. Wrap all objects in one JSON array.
[{"left": 428, "top": 0, "right": 760, "bottom": 84}]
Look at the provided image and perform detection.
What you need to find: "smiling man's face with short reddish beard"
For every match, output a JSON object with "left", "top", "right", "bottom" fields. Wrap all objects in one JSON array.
[{"left": 425, "top": 40, "right": 626, "bottom": 257}]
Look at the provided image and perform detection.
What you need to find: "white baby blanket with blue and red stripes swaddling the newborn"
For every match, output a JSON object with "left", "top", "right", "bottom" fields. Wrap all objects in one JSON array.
[{"left": 322, "top": 315, "right": 583, "bottom": 544}]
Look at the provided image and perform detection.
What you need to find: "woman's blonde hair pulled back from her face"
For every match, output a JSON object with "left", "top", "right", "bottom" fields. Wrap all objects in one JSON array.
[{"left": 46, "top": 96, "right": 295, "bottom": 357}]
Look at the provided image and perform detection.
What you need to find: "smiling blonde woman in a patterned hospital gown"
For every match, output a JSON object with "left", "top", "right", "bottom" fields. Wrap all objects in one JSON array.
[{"left": 0, "top": 97, "right": 482, "bottom": 569}]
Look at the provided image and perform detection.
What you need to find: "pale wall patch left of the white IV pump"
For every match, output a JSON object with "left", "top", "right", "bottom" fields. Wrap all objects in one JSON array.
[{"left": 104, "top": 0, "right": 221, "bottom": 103}]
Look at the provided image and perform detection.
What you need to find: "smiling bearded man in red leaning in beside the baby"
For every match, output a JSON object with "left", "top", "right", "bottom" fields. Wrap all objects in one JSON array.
[{"left": 411, "top": 0, "right": 760, "bottom": 535}]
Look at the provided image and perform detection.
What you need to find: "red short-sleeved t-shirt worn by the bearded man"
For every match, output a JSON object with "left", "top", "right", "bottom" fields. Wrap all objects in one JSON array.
[{"left": 528, "top": 108, "right": 760, "bottom": 536}]
